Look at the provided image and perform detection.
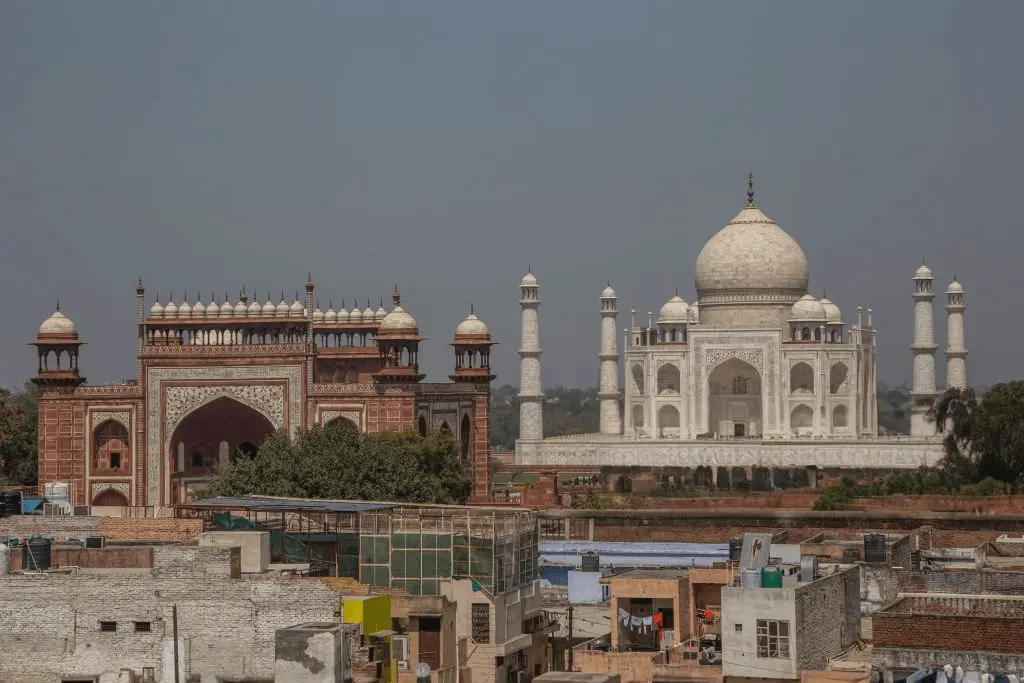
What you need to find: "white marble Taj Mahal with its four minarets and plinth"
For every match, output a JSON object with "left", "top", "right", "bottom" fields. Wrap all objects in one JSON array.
[{"left": 516, "top": 178, "right": 967, "bottom": 477}]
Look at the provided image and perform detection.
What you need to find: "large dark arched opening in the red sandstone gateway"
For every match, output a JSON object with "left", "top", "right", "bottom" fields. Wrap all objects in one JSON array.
[{"left": 171, "top": 396, "right": 273, "bottom": 504}]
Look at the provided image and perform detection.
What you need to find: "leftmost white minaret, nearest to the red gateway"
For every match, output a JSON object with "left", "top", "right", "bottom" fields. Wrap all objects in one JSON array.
[{"left": 519, "top": 272, "right": 544, "bottom": 440}]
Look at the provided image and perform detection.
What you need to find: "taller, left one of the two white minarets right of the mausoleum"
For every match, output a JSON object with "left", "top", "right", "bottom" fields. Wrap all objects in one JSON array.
[{"left": 910, "top": 263, "right": 936, "bottom": 436}]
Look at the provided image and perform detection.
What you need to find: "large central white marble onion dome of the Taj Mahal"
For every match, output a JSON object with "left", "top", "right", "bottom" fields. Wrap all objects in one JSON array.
[{"left": 695, "top": 202, "right": 808, "bottom": 303}]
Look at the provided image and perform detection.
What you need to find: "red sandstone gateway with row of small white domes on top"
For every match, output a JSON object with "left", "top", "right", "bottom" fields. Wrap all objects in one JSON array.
[{"left": 33, "top": 281, "right": 494, "bottom": 506}]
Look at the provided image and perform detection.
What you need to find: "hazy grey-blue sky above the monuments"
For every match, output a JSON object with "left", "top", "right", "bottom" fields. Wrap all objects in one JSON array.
[{"left": 0, "top": 0, "right": 1024, "bottom": 386}]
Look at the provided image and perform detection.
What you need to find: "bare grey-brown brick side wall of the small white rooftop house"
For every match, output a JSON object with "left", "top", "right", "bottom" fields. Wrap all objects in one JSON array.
[{"left": 796, "top": 567, "right": 860, "bottom": 670}]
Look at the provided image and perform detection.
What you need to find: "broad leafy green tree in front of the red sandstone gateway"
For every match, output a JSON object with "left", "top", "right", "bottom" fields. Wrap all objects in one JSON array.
[{"left": 204, "top": 426, "right": 472, "bottom": 503}]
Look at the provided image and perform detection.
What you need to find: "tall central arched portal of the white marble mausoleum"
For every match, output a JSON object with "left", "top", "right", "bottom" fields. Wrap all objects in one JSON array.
[{"left": 708, "top": 358, "right": 762, "bottom": 437}]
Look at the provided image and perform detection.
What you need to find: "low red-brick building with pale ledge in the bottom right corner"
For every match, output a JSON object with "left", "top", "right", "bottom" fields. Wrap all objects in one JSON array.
[{"left": 871, "top": 594, "right": 1024, "bottom": 680}]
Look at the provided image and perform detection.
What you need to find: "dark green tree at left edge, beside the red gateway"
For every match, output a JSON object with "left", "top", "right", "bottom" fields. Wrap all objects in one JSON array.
[{"left": 0, "top": 384, "right": 39, "bottom": 485}]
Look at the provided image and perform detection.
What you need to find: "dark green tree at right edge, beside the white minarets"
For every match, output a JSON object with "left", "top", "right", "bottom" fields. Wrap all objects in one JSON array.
[{"left": 930, "top": 381, "right": 1024, "bottom": 484}]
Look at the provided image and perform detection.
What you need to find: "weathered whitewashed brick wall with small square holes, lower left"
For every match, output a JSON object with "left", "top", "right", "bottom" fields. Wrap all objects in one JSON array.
[{"left": 0, "top": 548, "right": 340, "bottom": 683}]
